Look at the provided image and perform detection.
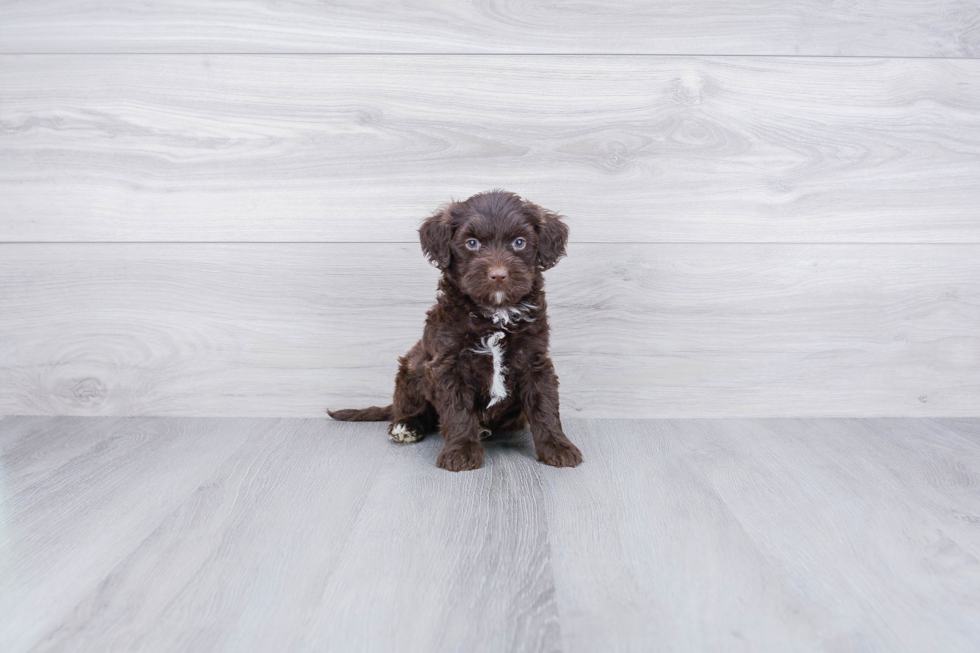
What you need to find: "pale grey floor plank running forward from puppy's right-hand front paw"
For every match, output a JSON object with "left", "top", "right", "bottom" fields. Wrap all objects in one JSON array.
[{"left": 541, "top": 420, "right": 837, "bottom": 651}]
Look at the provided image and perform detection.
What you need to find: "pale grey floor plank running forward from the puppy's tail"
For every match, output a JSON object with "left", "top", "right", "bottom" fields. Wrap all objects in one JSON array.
[{"left": 24, "top": 420, "right": 396, "bottom": 652}]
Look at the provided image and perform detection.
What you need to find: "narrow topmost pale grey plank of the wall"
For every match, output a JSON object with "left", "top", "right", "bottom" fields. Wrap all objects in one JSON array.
[{"left": 0, "top": 0, "right": 980, "bottom": 57}]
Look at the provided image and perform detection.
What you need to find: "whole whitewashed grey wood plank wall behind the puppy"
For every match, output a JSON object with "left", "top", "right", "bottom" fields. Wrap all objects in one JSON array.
[{"left": 0, "top": 0, "right": 980, "bottom": 417}]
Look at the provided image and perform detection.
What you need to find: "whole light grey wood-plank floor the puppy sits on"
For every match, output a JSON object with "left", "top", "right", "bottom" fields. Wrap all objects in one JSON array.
[{"left": 0, "top": 417, "right": 980, "bottom": 652}]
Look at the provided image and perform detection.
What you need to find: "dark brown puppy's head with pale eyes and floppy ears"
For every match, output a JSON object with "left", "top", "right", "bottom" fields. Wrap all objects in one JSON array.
[{"left": 419, "top": 190, "right": 568, "bottom": 308}]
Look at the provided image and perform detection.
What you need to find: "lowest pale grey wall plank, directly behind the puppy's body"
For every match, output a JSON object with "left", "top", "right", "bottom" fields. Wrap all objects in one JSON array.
[{"left": 0, "top": 243, "right": 980, "bottom": 417}]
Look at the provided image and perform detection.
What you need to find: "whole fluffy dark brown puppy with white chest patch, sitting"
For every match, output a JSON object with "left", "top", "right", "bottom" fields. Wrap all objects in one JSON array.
[{"left": 327, "top": 190, "right": 582, "bottom": 472}]
